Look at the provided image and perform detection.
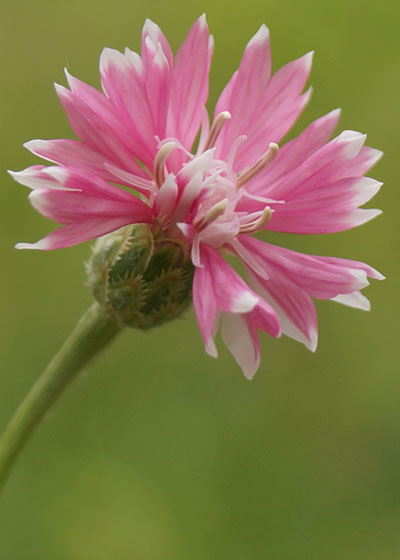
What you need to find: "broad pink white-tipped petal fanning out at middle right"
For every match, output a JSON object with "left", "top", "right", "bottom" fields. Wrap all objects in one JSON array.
[{"left": 245, "top": 128, "right": 381, "bottom": 233}]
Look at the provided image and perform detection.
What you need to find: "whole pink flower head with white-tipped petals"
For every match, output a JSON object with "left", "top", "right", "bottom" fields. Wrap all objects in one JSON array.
[{"left": 12, "top": 16, "right": 383, "bottom": 378}]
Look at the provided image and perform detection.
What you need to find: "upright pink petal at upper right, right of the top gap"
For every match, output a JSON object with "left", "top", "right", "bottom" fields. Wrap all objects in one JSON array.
[{"left": 216, "top": 47, "right": 312, "bottom": 171}]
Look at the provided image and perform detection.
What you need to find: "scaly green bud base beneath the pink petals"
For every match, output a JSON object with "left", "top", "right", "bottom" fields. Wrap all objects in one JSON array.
[{"left": 87, "top": 224, "right": 194, "bottom": 329}]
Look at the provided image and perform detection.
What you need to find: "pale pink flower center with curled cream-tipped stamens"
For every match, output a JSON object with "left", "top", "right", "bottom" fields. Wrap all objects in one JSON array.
[{"left": 153, "top": 111, "right": 279, "bottom": 252}]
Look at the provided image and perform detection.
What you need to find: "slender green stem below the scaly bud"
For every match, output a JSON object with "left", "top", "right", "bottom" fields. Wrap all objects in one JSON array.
[{"left": 0, "top": 303, "right": 120, "bottom": 489}]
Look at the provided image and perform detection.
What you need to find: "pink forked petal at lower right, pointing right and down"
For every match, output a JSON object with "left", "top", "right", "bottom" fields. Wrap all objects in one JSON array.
[{"left": 240, "top": 235, "right": 383, "bottom": 351}]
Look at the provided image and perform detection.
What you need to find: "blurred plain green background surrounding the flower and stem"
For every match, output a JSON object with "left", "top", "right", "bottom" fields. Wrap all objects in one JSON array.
[{"left": 0, "top": 0, "right": 400, "bottom": 560}]
